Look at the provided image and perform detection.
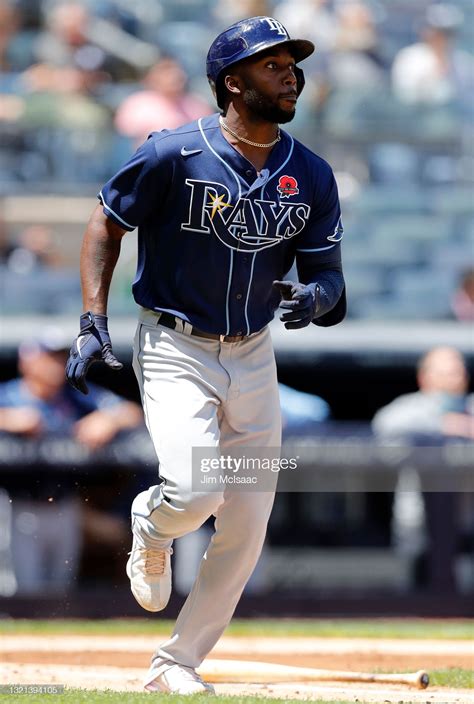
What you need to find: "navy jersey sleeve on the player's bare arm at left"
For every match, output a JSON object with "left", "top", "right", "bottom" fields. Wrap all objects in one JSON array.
[{"left": 98, "top": 136, "right": 166, "bottom": 232}]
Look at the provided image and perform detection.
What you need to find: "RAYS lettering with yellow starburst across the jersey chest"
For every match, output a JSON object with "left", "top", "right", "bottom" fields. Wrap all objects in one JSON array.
[{"left": 181, "top": 179, "right": 311, "bottom": 252}]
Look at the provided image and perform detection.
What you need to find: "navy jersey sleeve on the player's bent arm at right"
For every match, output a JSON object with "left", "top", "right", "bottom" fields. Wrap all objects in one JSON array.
[{"left": 296, "top": 162, "right": 344, "bottom": 266}]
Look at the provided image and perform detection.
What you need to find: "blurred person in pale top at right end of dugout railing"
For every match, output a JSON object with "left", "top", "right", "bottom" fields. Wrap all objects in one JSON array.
[{"left": 372, "top": 347, "right": 474, "bottom": 439}]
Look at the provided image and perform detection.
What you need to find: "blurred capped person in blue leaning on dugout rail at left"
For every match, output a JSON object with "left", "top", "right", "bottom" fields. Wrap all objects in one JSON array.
[{"left": 0, "top": 329, "right": 142, "bottom": 593}]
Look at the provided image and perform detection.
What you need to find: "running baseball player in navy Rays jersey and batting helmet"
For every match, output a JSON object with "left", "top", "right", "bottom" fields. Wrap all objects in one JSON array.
[{"left": 66, "top": 17, "right": 345, "bottom": 694}]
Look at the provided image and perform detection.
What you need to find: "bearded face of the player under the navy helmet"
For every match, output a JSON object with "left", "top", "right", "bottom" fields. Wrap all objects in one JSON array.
[{"left": 238, "top": 47, "right": 298, "bottom": 124}]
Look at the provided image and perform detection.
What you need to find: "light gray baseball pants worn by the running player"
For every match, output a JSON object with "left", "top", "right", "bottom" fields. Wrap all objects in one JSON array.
[{"left": 132, "top": 309, "right": 281, "bottom": 667}]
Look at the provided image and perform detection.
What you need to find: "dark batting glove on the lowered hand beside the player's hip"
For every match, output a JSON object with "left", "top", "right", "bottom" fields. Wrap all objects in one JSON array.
[{"left": 66, "top": 311, "right": 123, "bottom": 394}]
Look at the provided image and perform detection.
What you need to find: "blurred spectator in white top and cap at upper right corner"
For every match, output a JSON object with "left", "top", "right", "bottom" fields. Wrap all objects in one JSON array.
[{"left": 392, "top": 4, "right": 474, "bottom": 105}]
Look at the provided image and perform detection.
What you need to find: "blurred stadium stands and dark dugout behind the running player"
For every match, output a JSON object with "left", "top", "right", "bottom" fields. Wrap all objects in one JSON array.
[{"left": 0, "top": 0, "right": 474, "bottom": 617}]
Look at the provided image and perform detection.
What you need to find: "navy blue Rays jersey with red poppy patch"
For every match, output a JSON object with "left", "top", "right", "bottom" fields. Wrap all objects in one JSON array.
[{"left": 99, "top": 114, "right": 342, "bottom": 335}]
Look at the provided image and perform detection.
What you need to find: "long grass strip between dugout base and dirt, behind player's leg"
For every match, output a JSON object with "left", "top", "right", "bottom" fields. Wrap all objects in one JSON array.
[{"left": 0, "top": 617, "right": 474, "bottom": 640}]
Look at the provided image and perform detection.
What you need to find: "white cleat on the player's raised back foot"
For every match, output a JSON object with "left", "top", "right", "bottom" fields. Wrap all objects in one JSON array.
[{"left": 126, "top": 536, "right": 173, "bottom": 611}]
